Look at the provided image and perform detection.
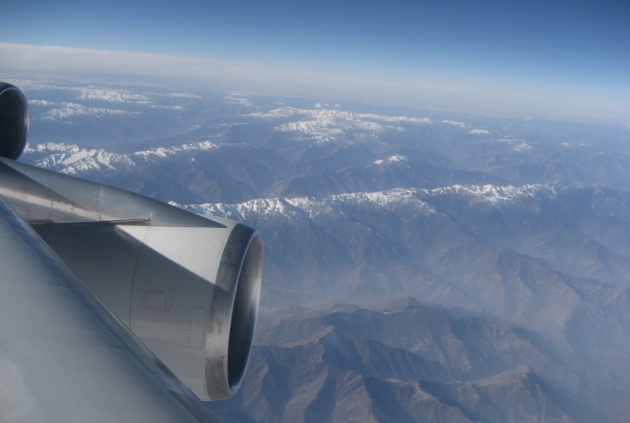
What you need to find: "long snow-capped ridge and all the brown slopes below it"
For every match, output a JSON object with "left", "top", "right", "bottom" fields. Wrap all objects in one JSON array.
[{"left": 198, "top": 185, "right": 630, "bottom": 422}]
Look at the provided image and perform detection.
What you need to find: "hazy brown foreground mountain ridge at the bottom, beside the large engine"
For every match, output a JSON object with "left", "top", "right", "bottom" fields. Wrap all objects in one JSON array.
[{"left": 210, "top": 298, "right": 609, "bottom": 422}]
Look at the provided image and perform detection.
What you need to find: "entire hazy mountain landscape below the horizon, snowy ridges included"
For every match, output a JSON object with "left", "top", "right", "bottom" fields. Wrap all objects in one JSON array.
[{"left": 18, "top": 81, "right": 630, "bottom": 422}]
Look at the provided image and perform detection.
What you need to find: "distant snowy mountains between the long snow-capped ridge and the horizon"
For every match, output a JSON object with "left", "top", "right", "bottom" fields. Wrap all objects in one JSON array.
[{"left": 25, "top": 80, "right": 630, "bottom": 203}]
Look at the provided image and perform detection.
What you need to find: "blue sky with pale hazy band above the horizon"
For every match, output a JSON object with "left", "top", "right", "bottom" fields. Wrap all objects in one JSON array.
[{"left": 0, "top": 0, "right": 630, "bottom": 122}]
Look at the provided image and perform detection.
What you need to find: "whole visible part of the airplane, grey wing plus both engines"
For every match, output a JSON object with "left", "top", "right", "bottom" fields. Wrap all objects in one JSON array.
[{"left": 0, "top": 83, "right": 262, "bottom": 422}]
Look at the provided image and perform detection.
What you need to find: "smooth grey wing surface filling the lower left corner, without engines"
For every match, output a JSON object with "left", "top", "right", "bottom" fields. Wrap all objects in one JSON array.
[{"left": 0, "top": 197, "right": 214, "bottom": 422}]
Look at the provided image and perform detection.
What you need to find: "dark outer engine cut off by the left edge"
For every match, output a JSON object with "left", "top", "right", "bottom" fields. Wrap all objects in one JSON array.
[{"left": 0, "top": 81, "right": 28, "bottom": 160}]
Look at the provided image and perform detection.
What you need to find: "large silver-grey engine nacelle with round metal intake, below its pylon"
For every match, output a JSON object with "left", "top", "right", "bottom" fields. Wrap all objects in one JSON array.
[{"left": 33, "top": 220, "right": 262, "bottom": 399}]
